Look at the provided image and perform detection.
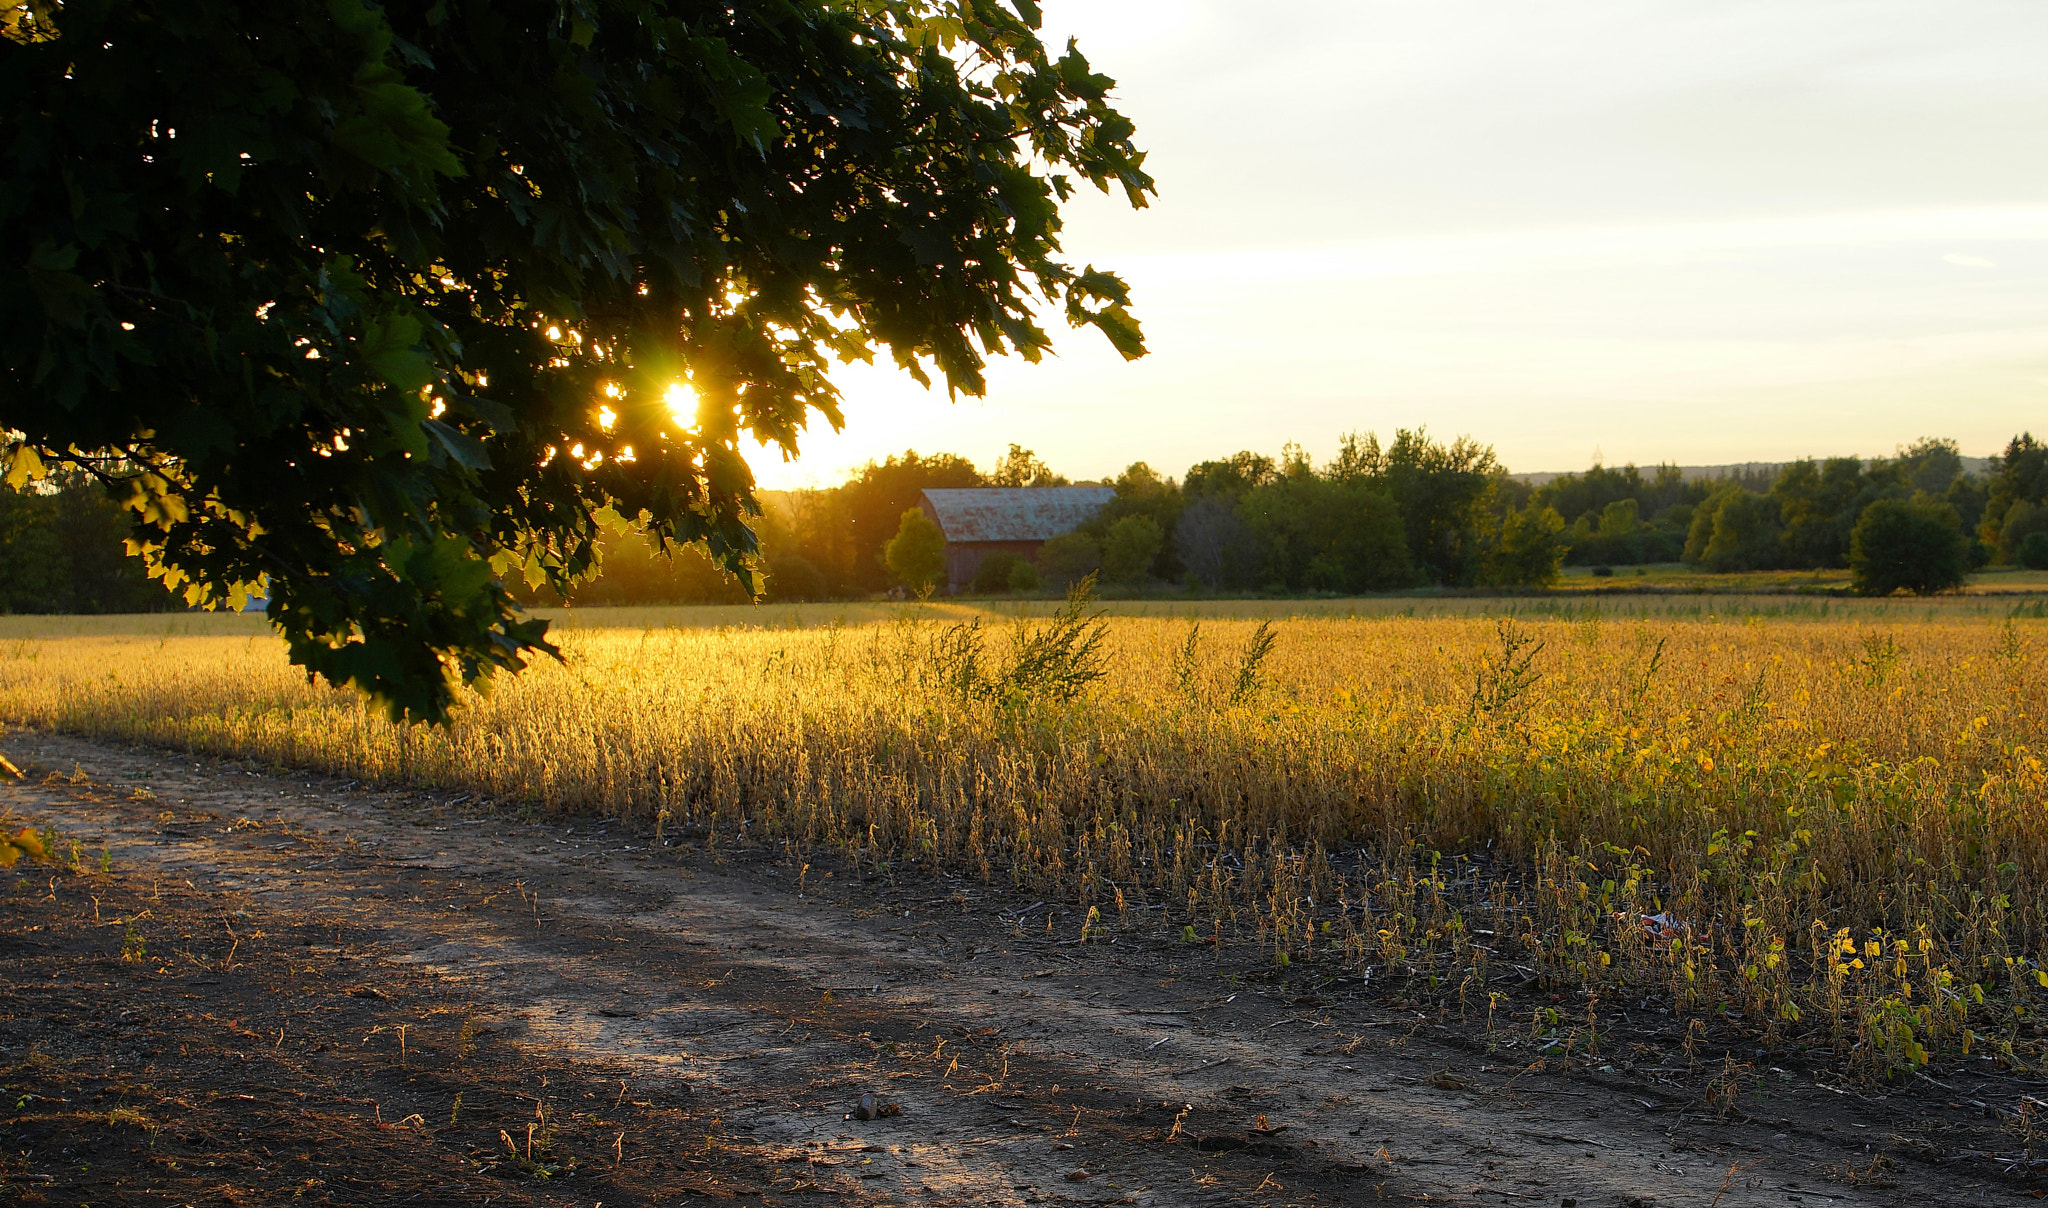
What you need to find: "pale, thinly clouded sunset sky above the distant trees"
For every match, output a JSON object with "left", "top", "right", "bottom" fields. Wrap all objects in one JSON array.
[{"left": 754, "top": 0, "right": 2048, "bottom": 487}]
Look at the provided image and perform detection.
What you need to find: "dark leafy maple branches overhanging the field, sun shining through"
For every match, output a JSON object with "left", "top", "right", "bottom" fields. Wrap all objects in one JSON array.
[{"left": 0, "top": 0, "right": 1153, "bottom": 721}]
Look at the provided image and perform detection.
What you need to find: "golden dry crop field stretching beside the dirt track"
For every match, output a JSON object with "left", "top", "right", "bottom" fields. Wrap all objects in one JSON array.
[{"left": 0, "top": 596, "right": 2048, "bottom": 1073}]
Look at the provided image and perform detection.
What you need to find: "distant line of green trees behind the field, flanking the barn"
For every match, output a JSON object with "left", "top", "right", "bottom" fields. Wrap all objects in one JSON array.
[{"left": 0, "top": 430, "right": 2048, "bottom": 612}]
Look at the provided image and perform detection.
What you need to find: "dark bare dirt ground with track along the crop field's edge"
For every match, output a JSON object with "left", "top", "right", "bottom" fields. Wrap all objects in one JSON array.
[{"left": 0, "top": 731, "right": 2048, "bottom": 1208}]
